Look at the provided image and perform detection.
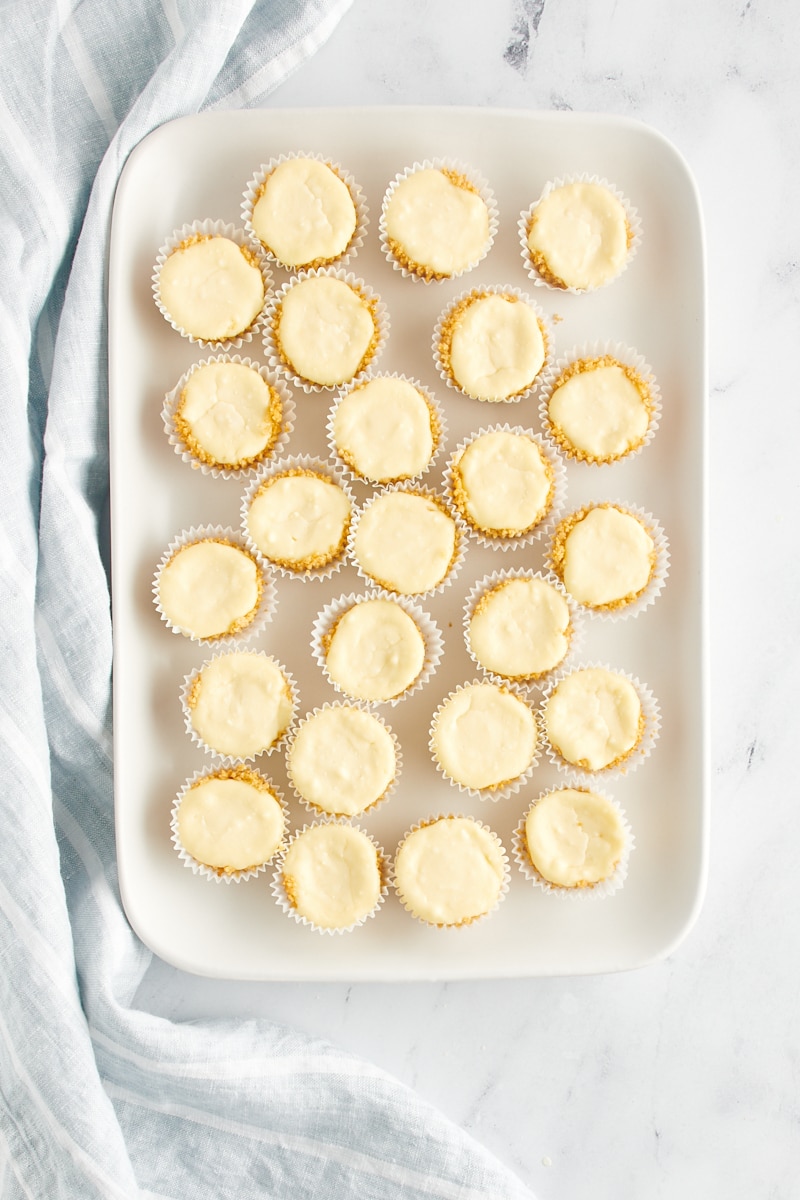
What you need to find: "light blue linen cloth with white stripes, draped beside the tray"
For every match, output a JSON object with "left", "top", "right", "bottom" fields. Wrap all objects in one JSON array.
[{"left": 0, "top": 0, "right": 530, "bottom": 1200}]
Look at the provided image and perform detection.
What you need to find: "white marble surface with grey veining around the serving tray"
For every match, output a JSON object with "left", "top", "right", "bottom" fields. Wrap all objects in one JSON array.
[{"left": 138, "top": 0, "right": 800, "bottom": 1200}]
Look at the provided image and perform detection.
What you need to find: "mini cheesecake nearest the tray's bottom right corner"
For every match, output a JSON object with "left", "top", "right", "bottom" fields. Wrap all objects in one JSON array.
[{"left": 521, "top": 787, "right": 628, "bottom": 888}]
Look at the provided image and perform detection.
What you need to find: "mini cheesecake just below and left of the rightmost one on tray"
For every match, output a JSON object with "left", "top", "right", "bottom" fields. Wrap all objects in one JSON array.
[{"left": 467, "top": 575, "right": 573, "bottom": 682}]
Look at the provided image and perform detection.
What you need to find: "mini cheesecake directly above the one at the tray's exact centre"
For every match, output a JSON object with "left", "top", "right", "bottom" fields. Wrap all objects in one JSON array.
[{"left": 330, "top": 376, "right": 441, "bottom": 484}]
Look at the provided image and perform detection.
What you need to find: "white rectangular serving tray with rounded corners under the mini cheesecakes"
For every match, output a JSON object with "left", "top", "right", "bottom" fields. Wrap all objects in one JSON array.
[{"left": 109, "top": 108, "right": 709, "bottom": 980}]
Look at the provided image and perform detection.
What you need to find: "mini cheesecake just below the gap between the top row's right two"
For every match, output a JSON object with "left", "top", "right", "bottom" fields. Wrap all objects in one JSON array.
[{"left": 435, "top": 289, "right": 547, "bottom": 401}]
